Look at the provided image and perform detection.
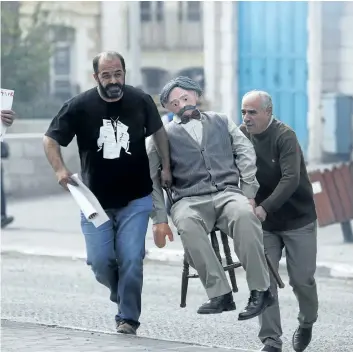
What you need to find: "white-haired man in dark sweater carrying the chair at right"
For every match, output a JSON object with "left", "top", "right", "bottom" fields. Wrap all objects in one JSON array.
[{"left": 241, "top": 91, "right": 318, "bottom": 352}]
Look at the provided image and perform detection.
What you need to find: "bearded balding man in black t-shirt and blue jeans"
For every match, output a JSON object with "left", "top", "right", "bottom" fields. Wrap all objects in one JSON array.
[{"left": 44, "top": 52, "right": 171, "bottom": 334}]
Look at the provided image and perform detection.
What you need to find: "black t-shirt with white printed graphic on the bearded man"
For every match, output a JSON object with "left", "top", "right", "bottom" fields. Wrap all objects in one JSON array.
[{"left": 46, "top": 86, "right": 163, "bottom": 209}]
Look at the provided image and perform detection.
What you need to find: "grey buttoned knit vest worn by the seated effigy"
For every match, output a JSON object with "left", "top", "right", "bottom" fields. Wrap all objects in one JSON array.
[{"left": 166, "top": 111, "right": 241, "bottom": 201}]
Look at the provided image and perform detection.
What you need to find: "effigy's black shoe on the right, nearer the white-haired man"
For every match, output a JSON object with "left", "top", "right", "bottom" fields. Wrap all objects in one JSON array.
[{"left": 238, "top": 290, "right": 275, "bottom": 320}]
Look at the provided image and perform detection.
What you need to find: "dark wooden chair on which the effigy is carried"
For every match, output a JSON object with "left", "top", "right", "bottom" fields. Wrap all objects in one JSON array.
[{"left": 165, "top": 188, "right": 284, "bottom": 308}]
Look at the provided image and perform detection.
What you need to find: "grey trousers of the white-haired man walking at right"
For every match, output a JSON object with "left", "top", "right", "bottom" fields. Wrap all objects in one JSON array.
[{"left": 259, "top": 222, "right": 318, "bottom": 347}]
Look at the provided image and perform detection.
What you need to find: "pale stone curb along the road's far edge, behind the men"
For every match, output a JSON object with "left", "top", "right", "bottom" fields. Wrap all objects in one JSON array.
[{"left": 1, "top": 246, "right": 353, "bottom": 279}]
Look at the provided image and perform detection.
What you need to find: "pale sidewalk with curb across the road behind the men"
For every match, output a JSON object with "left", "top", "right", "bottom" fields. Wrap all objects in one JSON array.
[{"left": 1, "top": 194, "right": 353, "bottom": 278}]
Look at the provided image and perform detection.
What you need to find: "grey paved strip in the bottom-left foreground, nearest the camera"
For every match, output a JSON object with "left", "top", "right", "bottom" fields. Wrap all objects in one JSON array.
[{"left": 1, "top": 320, "right": 253, "bottom": 352}]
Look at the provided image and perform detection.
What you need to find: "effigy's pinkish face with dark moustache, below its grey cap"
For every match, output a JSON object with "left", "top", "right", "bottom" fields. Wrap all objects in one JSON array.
[{"left": 166, "top": 87, "right": 198, "bottom": 117}]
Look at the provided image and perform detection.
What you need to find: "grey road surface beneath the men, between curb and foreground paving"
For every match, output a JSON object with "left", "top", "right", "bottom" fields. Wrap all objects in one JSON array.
[{"left": 1, "top": 254, "right": 353, "bottom": 352}]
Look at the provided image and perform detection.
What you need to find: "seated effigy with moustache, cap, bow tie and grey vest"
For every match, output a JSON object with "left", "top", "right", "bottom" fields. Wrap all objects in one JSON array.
[{"left": 147, "top": 77, "right": 273, "bottom": 320}]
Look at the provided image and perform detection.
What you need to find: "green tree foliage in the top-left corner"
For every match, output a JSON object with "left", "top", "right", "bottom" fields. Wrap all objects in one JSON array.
[{"left": 1, "top": 1, "right": 51, "bottom": 103}]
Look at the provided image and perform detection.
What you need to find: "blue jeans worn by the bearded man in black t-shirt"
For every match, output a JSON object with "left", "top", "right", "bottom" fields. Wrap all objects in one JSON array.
[{"left": 81, "top": 195, "right": 153, "bottom": 327}]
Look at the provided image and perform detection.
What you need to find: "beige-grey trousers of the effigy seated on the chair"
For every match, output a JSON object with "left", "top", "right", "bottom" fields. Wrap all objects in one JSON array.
[{"left": 171, "top": 189, "right": 270, "bottom": 298}]
